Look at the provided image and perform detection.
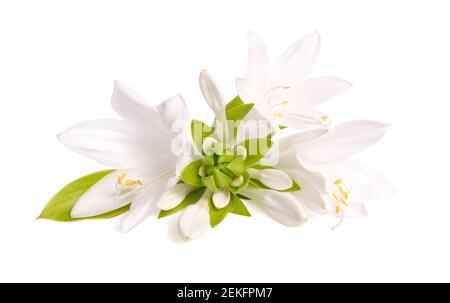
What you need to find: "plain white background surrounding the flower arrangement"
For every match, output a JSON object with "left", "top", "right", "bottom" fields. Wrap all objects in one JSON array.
[{"left": 0, "top": 0, "right": 450, "bottom": 282}]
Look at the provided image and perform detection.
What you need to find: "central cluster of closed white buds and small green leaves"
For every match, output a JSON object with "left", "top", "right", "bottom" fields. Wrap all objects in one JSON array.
[{"left": 158, "top": 71, "right": 306, "bottom": 240}]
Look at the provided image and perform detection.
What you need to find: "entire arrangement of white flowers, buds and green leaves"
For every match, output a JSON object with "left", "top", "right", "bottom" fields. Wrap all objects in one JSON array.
[{"left": 40, "top": 33, "right": 394, "bottom": 240}]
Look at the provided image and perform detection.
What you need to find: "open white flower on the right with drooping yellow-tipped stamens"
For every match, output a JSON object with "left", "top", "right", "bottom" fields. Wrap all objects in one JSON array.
[{"left": 277, "top": 120, "right": 394, "bottom": 228}]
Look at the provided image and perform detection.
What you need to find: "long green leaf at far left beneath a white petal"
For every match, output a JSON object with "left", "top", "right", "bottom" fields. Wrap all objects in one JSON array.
[{"left": 37, "top": 170, "right": 130, "bottom": 222}]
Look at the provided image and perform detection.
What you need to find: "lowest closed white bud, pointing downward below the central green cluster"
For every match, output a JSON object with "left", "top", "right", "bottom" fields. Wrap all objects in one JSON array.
[{"left": 178, "top": 197, "right": 210, "bottom": 241}]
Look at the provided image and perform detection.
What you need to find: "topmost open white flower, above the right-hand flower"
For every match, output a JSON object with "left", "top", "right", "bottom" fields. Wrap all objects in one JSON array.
[{"left": 236, "top": 32, "right": 351, "bottom": 129}]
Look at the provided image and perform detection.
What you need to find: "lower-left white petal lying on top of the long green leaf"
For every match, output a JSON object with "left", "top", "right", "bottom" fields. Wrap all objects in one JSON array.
[{"left": 70, "top": 171, "right": 131, "bottom": 218}]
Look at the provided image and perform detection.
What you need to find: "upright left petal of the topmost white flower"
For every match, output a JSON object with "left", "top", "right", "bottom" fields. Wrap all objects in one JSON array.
[{"left": 236, "top": 32, "right": 268, "bottom": 103}]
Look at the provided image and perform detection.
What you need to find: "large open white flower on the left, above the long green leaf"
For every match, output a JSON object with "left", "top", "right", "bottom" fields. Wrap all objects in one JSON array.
[{"left": 58, "top": 81, "right": 189, "bottom": 232}]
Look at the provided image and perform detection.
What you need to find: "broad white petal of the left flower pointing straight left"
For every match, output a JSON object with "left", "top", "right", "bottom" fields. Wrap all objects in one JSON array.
[{"left": 58, "top": 119, "right": 173, "bottom": 168}]
